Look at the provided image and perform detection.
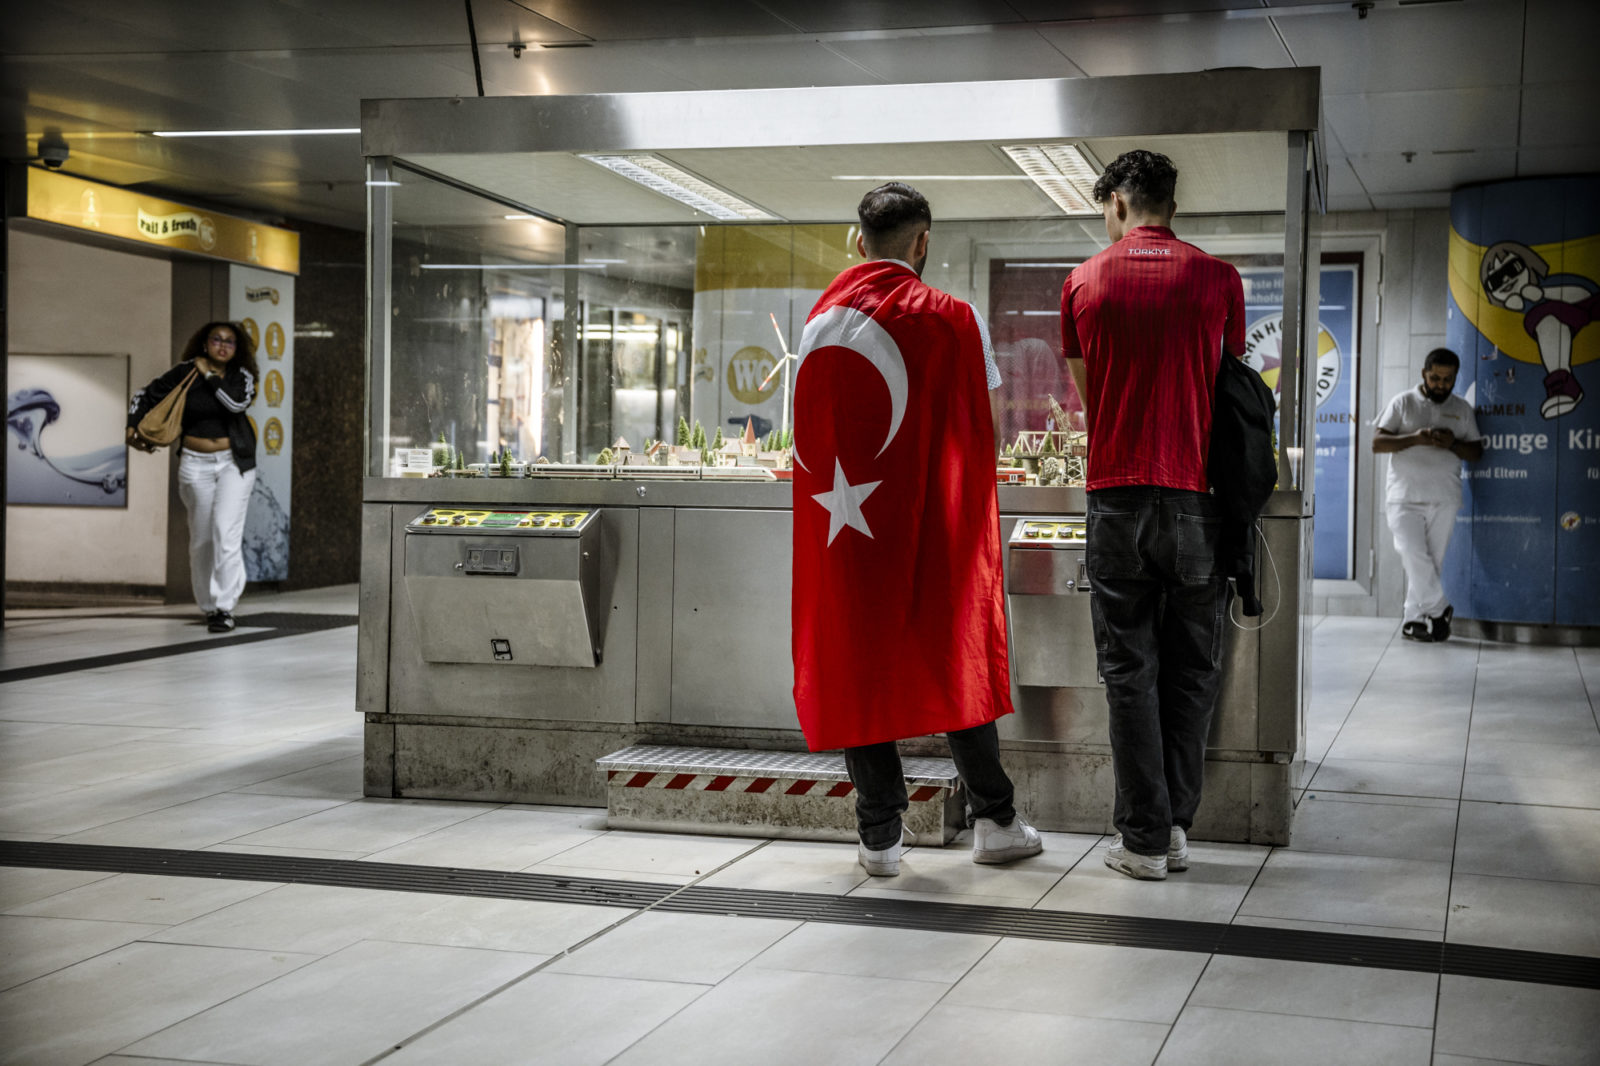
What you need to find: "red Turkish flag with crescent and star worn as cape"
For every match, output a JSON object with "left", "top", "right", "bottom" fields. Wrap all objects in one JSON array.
[{"left": 792, "top": 261, "right": 1011, "bottom": 751}]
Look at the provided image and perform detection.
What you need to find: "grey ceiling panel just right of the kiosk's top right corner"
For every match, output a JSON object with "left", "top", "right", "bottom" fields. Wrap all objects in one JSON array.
[{"left": 1322, "top": 90, "right": 1517, "bottom": 155}]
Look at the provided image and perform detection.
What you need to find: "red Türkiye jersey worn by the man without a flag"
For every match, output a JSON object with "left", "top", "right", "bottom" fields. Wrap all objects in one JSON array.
[{"left": 1061, "top": 226, "right": 1245, "bottom": 491}]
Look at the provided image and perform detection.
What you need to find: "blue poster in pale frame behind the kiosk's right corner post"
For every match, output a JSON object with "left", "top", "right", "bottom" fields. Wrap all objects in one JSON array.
[{"left": 1238, "top": 262, "right": 1360, "bottom": 581}]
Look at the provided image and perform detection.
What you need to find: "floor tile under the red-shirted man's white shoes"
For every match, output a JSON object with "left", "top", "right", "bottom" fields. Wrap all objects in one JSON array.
[{"left": 1035, "top": 842, "right": 1270, "bottom": 922}]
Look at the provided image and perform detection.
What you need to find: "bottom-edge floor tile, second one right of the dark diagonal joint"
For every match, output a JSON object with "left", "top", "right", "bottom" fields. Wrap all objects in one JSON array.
[{"left": 614, "top": 970, "right": 949, "bottom": 1066}]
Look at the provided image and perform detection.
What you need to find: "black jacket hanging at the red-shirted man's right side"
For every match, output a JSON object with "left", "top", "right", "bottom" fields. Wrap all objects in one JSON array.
[{"left": 1206, "top": 354, "right": 1278, "bottom": 616}]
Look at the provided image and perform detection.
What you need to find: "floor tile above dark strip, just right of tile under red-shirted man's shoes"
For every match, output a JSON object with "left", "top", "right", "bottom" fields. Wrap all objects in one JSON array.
[{"left": 1240, "top": 850, "right": 1450, "bottom": 930}]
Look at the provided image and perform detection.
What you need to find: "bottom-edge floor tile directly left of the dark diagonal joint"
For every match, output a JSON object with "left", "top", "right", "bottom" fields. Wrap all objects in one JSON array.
[{"left": 123, "top": 941, "right": 544, "bottom": 1066}]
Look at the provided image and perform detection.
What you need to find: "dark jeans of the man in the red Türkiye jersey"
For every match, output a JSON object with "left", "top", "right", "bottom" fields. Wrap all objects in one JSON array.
[{"left": 1086, "top": 485, "right": 1230, "bottom": 855}]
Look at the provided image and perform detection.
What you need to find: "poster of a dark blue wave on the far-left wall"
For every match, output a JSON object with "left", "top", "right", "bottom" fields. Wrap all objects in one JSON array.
[{"left": 5, "top": 354, "right": 128, "bottom": 507}]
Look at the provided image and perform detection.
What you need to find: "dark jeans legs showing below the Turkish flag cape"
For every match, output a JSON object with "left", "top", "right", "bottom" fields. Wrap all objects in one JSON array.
[{"left": 845, "top": 722, "right": 1016, "bottom": 852}]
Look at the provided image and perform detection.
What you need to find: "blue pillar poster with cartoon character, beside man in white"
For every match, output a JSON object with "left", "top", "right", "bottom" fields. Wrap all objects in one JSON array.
[{"left": 1445, "top": 176, "right": 1600, "bottom": 626}]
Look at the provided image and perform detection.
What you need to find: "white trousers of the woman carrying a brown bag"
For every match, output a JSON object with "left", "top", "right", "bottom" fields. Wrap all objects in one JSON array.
[{"left": 178, "top": 448, "right": 256, "bottom": 615}]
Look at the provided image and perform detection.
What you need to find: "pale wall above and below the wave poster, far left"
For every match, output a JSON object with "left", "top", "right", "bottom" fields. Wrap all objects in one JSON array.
[{"left": 5, "top": 227, "right": 173, "bottom": 586}]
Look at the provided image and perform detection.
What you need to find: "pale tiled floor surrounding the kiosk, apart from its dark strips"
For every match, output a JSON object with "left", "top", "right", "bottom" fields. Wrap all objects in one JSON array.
[{"left": 0, "top": 589, "right": 1600, "bottom": 1066}]
